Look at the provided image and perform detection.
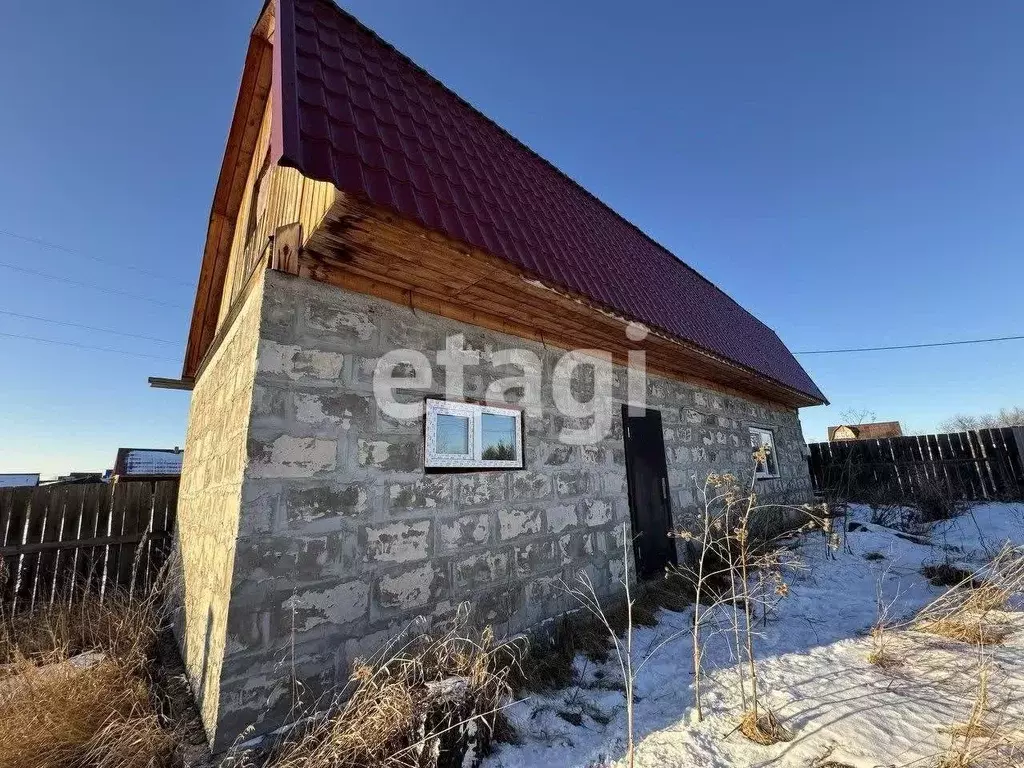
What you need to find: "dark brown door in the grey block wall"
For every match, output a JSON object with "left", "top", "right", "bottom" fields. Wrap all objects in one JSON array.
[{"left": 623, "top": 406, "right": 676, "bottom": 579}]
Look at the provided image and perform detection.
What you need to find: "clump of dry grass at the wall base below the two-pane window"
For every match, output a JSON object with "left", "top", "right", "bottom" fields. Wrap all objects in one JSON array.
[{"left": 267, "top": 611, "right": 522, "bottom": 768}]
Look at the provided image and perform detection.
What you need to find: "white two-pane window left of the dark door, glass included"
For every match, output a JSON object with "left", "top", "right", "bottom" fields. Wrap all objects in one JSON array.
[{"left": 424, "top": 398, "right": 523, "bottom": 469}]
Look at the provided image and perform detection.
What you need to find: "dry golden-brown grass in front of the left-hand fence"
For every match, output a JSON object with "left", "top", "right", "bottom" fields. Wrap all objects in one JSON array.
[{"left": 0, "top": 596, "right": 176, "bottom": 768}]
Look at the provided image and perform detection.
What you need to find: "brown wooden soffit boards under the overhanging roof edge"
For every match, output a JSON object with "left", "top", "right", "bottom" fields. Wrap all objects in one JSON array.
[{"left": 299, "top": 193, "right": 818, "bottom": 408}]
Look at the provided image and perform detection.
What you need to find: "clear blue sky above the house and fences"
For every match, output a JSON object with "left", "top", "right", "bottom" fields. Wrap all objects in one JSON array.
[{"left": 0, "top": 0, "right": 1024, "bottom": 481}]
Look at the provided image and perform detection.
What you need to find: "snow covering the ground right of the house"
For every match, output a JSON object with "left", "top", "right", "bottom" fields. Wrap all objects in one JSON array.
[{"left": 486, "top": 504, "right": 1024, "bottom": 768}]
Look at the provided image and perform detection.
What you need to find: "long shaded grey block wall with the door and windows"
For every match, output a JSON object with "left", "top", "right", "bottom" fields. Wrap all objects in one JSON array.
[{"left": 195, "top": 272, "right": 809, "bottom": 744}]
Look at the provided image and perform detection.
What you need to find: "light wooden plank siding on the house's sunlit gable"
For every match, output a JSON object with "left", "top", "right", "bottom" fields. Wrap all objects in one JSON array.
[{"left": 217, "top": 98, "right": 336, "bottom": 332}]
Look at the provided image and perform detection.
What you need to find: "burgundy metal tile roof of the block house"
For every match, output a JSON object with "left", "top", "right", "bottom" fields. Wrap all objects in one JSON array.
[{"left": 272, "top": 0, "right": 824, "bottom": 401}]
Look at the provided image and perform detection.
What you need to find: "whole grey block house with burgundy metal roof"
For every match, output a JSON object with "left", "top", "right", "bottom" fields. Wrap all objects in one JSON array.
[{"left": 176, "top": 0, "right": 825, "bottom": 749}]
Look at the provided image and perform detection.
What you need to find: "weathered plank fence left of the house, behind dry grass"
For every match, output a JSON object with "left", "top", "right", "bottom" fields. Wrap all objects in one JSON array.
[{"left": 0, "top": 479, "right": 178, "bottom": 610}]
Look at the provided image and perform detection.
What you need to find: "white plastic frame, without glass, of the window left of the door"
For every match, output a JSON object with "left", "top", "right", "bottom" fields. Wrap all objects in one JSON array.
[{"left": 423, "top": 397, "right": 526, "bottom": 471}]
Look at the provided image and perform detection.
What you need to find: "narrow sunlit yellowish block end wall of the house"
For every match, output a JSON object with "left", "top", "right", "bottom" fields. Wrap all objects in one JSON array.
[{"left": 172, "top": 274, "right": 262, "bottom": 737}]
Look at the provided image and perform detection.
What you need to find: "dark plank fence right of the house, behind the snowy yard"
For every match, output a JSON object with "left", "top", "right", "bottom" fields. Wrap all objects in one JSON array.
[{"left": 808, "top": 427, "right": 1024, "bottom": 501}]
